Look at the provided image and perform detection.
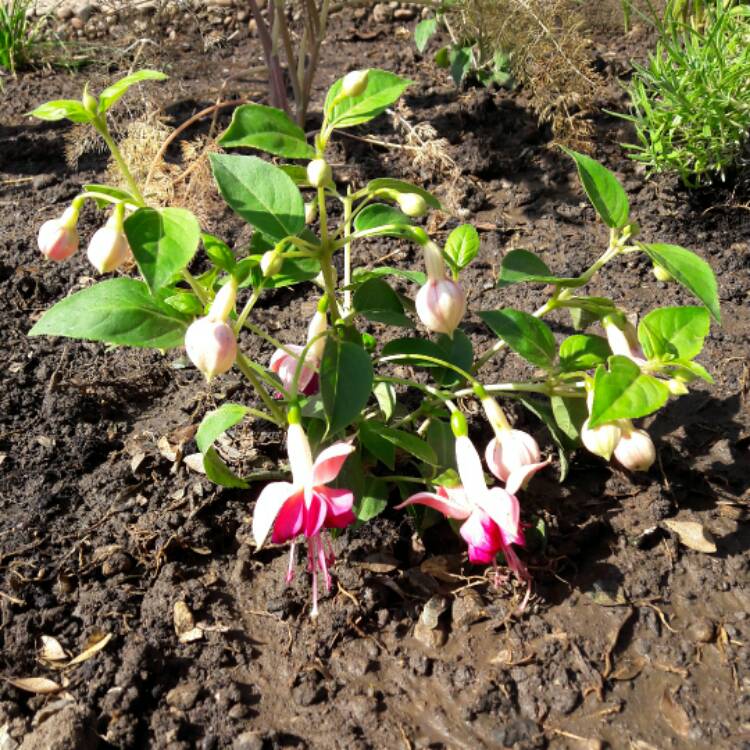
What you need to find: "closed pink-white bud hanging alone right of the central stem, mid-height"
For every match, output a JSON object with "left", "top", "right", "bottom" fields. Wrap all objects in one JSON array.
[{"left": 414, "top": 242, "right": 466, "bottom": 336}]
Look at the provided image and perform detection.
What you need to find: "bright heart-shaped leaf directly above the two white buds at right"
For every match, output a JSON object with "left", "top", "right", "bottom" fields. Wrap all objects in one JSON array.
[{"left": 589, "top": 355, "right": 669, "bottom": 427}]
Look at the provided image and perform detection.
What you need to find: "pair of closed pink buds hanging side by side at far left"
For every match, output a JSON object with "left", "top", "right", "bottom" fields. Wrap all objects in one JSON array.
[{"left": 38, "top": 200, "right": 131, "bottom": 273}]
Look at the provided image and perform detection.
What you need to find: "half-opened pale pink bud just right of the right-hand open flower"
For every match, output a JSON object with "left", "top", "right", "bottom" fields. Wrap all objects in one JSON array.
[{"left": 482, "top": 396, "right": 550, "bottom": 495}]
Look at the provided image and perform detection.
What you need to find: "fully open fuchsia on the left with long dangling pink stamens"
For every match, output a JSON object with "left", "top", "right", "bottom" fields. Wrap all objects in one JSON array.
[{"left": 253, "top": 414, "right": 356, "bottom": 619}]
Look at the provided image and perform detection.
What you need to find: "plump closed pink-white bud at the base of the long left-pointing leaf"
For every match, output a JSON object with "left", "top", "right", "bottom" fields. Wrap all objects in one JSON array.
[{"left": 185, "top": 276, "right": 237, "bottom": 381}]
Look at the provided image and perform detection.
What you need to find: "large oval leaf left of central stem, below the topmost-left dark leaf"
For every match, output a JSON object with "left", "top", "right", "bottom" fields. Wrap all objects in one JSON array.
[{"left": 209, "top": 154, "right": 305, "bottom": 241}]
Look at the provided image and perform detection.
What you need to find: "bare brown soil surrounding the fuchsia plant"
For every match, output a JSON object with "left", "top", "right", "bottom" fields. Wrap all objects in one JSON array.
[{"left": 0, "top": 10, "right": 750, "bottom": 750}]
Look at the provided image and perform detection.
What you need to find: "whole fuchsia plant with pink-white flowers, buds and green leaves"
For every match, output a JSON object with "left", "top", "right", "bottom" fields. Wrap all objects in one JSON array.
[{"left": 30, "top": 70, "right": 720, "bottom": 616}]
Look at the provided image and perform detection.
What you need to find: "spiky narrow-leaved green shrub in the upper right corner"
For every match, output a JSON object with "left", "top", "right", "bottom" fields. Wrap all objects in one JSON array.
[{"left": 623, "top": 0, "right": 750, "bottom": 187}]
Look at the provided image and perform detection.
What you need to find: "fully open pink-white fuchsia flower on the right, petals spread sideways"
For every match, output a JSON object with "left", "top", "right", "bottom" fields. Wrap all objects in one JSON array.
[{"left": 397, "top": 412, "right": 529, "bottom": 581}]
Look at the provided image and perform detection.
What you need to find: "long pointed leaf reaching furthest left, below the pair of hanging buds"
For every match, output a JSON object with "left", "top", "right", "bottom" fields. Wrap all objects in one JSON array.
[{"left": 29, "top": 277, "right": 190, "bottom": 349}]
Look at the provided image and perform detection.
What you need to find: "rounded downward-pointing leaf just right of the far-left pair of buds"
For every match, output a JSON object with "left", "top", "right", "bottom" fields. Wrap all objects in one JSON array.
[{"left": 125, "top": 208, "right": 201, "bottom": 293}]
